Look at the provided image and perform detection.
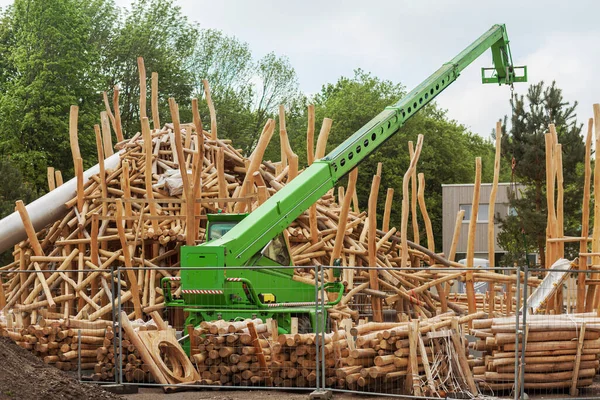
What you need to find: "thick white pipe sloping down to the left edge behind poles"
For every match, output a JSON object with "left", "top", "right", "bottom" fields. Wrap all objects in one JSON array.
[{"left": 0, "top": 152, "right": 120, "bottom": 252}]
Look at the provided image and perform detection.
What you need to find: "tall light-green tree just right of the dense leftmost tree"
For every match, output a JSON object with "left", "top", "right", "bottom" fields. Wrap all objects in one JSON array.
[{"left": 104, "top": 0, "right": 198, "bottom": 136}]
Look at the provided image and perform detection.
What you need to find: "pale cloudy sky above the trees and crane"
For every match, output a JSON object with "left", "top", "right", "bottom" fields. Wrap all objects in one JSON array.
[{"left": 0, "top": 0, "right": 600, "bottom": 137}]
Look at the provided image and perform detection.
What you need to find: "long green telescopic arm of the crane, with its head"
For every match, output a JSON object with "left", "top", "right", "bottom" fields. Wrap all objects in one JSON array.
[{"left": 194, "top": 25, "right": 527, "bottom": 266}]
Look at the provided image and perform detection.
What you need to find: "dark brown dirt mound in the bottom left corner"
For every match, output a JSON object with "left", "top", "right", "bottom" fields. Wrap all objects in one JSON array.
[{"left": 0, "top": 337, "right": 123, "bottom": 400}]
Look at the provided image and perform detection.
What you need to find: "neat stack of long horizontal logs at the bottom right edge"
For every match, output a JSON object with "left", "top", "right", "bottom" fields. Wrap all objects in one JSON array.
[{"left": 471, "top": 312, "right": 600, "bottom": 395}]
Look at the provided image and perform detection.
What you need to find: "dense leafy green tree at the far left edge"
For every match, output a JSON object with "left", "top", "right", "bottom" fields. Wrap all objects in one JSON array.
[{"left": 0, "top": 0, "right": 113, "bottom": 189}]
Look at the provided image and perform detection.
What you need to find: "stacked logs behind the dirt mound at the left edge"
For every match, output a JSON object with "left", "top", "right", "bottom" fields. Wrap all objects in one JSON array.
[{"left": 0, "top": 313, "right": 112, "bottom": 371}]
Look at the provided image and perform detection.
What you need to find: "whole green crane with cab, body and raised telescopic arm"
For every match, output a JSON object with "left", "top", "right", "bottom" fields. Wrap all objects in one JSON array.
[{"left": 162, "top": 25, "right": 527, "bottom": 340}]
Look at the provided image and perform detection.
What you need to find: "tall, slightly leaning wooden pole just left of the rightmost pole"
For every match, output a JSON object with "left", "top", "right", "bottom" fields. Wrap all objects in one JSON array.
[{"left": 577, "top": 118, "right": 594, "bottom": 313}]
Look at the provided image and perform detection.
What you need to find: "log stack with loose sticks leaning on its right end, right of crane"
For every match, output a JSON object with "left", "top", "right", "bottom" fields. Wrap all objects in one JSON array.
[{"left": 335, "top": 313, "right": 482, "bottom": 397}]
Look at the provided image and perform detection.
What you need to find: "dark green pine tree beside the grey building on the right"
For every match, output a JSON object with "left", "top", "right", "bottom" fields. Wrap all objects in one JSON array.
[{"left": 498, "top": 82, "right": 585, "bottom": 265}]
